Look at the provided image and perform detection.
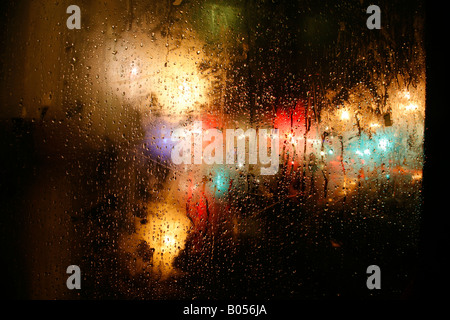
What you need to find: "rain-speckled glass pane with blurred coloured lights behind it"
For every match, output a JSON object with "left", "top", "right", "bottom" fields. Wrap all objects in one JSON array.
[{"left": 0, "top": 0, "right": 426, "bottom": 300}]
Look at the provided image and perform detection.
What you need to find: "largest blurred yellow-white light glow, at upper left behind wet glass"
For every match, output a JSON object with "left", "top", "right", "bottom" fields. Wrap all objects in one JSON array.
[{"left": 106, "top": 33, "right": 211, "bottom": 115}]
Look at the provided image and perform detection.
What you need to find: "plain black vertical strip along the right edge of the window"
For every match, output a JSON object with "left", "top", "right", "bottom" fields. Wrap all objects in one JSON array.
[{"left": 413, "top": 2, "right": 450, "bottom": 300}]
